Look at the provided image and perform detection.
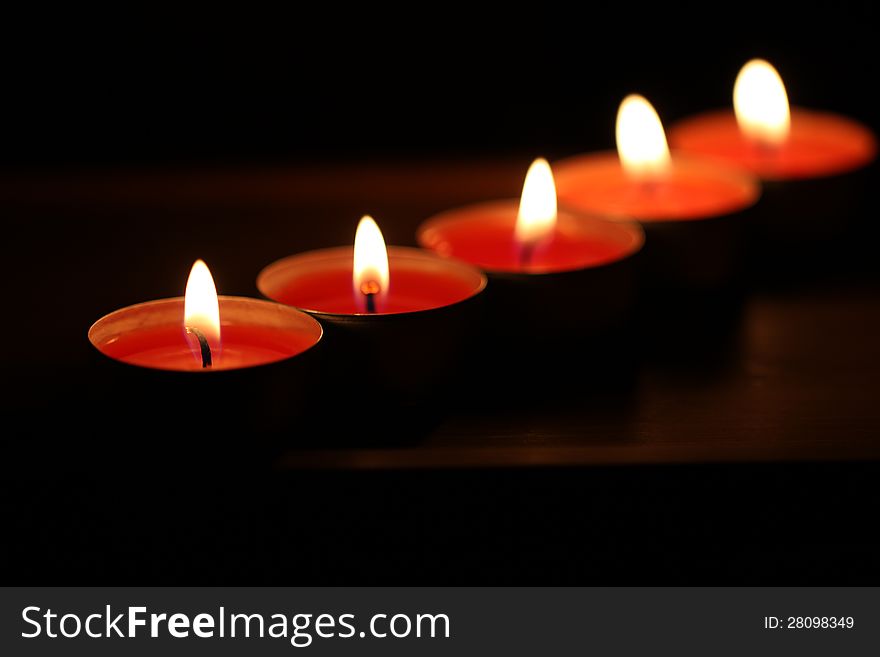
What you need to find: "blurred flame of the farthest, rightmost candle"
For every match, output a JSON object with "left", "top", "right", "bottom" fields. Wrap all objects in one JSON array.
[{"left": 733, "top": 59, "right": 791, "bottom": 147}]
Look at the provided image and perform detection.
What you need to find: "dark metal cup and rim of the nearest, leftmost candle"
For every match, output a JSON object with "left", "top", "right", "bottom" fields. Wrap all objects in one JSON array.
[{"left": 89, "top": 296, "right": 322, "bottom": 469}]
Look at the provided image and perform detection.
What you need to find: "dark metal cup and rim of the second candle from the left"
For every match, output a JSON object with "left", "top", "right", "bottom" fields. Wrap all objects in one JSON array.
[{"left": 257, "top": 247, "right": 487, "bottom": 426}]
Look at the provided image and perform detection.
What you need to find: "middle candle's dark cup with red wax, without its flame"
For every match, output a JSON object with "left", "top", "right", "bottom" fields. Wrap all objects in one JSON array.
[{"left": 417, "top": 200, "right": 644, "bottom": 393}]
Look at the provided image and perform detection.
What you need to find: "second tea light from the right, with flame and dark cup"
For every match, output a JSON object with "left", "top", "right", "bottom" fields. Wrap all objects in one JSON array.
[{"left": 554, "top": 95, "right": 760, "bottom": 288}]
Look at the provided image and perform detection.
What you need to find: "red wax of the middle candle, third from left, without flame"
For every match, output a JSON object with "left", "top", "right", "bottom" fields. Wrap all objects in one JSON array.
[{"left": 417, "top": 200, "right": 644, "bottom": 274}]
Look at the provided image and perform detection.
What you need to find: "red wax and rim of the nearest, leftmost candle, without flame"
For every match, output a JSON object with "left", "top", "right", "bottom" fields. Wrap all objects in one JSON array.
[{"left": 89, "top": 297, "right": 321, "bottom": 372}]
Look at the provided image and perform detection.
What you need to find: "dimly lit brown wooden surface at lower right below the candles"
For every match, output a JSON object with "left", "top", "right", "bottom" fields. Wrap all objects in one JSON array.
[{"left": 283, "top": 286, "right": 880, "bottom": 468}]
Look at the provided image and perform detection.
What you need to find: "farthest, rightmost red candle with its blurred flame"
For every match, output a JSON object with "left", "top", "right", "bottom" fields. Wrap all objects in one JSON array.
[{"left": 669, "top": 60, "right": 877, "bottom": 181}]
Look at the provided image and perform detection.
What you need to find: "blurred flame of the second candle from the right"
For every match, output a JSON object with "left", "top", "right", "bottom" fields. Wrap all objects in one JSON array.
[{"left": 616, "top": 94, "right": 671, "bottom": 182}]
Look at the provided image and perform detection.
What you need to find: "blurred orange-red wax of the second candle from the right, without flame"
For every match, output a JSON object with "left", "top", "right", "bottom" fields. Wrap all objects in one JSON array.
[{"left": 553, "top": 151, "right": 760, "bottom": 221}]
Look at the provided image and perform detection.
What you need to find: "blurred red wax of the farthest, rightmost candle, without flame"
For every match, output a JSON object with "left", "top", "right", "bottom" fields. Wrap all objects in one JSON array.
[{"left": 669, "top": 108, "right": 877, "bottom": 180}]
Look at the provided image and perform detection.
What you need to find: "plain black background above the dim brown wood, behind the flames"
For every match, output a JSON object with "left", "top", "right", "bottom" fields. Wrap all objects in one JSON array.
[{"left": 0, "top": 0, "right": 878, "bottom": 167}]
